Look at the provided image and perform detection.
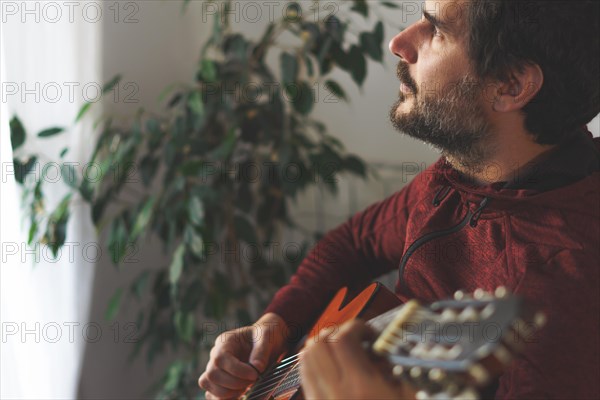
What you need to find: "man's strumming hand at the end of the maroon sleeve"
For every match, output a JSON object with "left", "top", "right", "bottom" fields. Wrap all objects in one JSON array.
[{"left": 198, "top": 313, "right": 288, "bottom": 399}]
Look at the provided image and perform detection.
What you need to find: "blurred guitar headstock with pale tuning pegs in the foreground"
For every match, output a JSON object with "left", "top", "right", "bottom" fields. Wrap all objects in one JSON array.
[{"left": 373, "top": 287, "right": 545, "bottom": 399}]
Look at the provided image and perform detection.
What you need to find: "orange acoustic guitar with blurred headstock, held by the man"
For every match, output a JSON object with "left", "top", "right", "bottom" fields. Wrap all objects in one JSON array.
[{"left": 242, "top": 283, "right": 545, "bottom": 400}]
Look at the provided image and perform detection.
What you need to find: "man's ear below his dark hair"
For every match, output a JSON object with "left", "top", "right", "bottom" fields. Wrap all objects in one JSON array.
[{"left": 492, "top": 64, "right": 544, "bottom": 112}]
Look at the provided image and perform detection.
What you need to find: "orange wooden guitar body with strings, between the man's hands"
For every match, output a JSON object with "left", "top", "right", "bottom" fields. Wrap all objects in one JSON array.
[{"left": 243, "top": 283, "right": 401, "bottom": 400}]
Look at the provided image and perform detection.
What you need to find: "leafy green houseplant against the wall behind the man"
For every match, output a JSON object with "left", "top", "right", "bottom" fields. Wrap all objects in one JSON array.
[{"left": 11, "top": 1, "right": 404, "bottom": 398}]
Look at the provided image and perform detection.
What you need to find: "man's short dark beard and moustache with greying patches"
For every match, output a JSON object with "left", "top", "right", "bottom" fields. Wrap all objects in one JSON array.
[{"left": 390, "top": 63, "right": 493, "bottom": 171}]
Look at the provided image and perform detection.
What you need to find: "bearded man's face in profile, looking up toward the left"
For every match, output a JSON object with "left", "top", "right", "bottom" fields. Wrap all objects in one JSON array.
[{"left": 390, "top": 0, "right": 491, "bottom": 168}]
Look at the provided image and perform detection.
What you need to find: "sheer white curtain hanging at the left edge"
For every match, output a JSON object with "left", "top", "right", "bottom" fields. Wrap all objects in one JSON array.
[{"left": 0, "top": 1, "right": 102, "bottom": 399}]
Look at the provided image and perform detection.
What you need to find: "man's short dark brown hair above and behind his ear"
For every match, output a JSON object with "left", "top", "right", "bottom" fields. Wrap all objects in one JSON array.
[{"left": 467, "top": 0, "right": 600, "bottom": 144}]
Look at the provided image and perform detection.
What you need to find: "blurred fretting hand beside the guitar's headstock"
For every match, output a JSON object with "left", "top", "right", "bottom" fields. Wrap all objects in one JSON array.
[{"left": 300, "top": 320, "right": 415, "bottom": 399}]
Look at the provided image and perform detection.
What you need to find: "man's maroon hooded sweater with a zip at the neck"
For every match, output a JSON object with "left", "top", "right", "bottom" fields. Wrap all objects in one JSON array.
[{"left": 266, "top": 131, "right": 600, "bottom": 399}]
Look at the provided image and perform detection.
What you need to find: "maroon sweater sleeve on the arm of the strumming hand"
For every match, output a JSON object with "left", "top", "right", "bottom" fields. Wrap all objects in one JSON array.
[{"left": 265, "top": 184, "right": 418, "bottom": 333}]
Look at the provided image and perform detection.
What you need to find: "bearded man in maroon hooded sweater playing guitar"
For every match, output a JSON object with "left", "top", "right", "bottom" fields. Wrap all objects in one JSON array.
[{"left": 199, "top": 0, "right": 600, "bottom": 398}]
